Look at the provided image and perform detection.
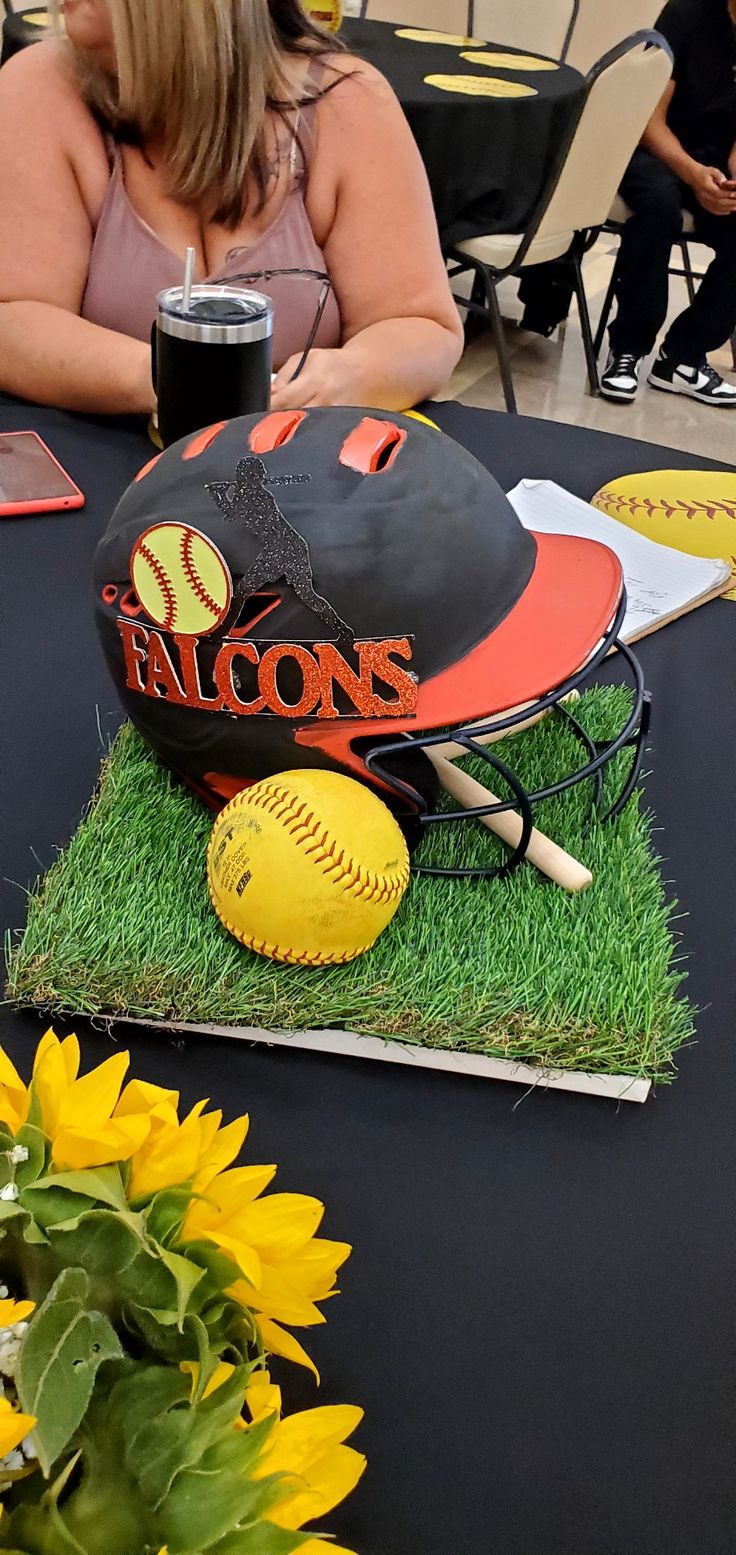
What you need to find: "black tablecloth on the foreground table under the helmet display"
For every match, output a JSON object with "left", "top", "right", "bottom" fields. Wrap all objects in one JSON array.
[{"left": 0, "top": 391, "right": 736, "bottom": 1555}]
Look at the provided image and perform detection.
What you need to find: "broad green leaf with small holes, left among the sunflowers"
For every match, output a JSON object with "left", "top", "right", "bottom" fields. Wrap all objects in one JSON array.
[{"left": 17, "top": 1269, "right": 123, "bottom": 1477}]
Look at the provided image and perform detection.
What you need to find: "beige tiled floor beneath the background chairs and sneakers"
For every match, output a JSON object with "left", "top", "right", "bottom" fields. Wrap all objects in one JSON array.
[{"left": 440, "top": 235, "right": 736, "bottom": 462}]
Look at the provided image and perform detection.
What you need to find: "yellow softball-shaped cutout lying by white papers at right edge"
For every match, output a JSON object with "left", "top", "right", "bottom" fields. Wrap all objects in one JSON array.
[{"left": 591, "top": 470, "right": 736, "bottom": 599}]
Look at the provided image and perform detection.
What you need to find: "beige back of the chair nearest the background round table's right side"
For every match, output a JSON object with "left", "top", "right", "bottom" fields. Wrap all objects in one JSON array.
[{"left": 535, "top": 34, "right": 672, "bottom": 241}]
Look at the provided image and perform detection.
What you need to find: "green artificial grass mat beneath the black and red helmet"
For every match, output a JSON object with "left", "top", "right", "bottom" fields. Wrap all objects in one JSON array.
[{"left": 6, "top": 686, "right": 692, "bottom": 1081}]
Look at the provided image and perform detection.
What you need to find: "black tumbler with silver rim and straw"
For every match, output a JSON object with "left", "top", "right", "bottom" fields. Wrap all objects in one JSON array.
[{"left": 151, "top": 285, "right": 274, "bottom": 448}]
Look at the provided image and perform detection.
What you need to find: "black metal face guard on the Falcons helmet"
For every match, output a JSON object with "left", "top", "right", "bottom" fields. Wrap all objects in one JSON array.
[{"left": 366, "top": 591, "right": 650, "bottom": 880}]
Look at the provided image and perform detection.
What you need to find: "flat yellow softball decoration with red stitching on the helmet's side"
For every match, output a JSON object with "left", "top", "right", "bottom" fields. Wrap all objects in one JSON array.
[{"left": 131, "top": 522, "right": 232, "bottom": 638}]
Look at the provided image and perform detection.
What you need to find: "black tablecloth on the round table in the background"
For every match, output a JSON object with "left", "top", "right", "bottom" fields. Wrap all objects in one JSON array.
[{"left": 342, "top": 20, "right": 584, "bottom": 247}]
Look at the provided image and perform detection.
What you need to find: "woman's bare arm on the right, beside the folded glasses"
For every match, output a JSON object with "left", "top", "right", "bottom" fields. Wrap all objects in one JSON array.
[{"left": 272, "top": 59, "right": 462, "bottom": 411}]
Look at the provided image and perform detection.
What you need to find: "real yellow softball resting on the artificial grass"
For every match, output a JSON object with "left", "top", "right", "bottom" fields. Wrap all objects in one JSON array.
[{"left": 207, "top": 768, "right": 409, "bottom": 967}]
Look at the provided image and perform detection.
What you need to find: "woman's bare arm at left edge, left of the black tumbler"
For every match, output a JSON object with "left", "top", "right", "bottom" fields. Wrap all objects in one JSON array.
[{"left": 0, "top": 44, "right": 154, "bottom": 414}]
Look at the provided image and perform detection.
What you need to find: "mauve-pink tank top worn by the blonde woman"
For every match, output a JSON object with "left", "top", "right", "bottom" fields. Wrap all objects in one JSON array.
[{"left": 81, "top": 70, "right": 341, "bottom": 369}]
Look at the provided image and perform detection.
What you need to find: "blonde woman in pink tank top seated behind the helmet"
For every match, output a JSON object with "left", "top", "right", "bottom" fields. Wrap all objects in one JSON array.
[{"left": 0, "top": 0, "right": 462, "bottom": 414}]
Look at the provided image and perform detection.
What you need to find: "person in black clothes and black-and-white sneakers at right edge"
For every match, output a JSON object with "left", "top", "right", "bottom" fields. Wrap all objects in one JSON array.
[{"left": 601, "top": 0, "right": 736, "bottom": 406}]
